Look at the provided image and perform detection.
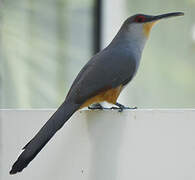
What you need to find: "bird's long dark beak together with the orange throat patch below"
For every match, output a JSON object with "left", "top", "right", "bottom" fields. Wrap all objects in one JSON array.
[{"left": 143, "top": 12, "right": 184, "bottom": 37}]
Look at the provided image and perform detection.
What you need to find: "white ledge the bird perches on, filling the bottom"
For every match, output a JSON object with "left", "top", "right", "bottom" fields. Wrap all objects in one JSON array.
[{"left": 0, "top": 109, "right": 195, "bottom": 180}]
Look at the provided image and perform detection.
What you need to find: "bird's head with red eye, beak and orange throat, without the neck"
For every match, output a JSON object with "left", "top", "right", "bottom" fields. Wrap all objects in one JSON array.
[{"left": 123, "top": 12, "right": 184, "bottom": 38}]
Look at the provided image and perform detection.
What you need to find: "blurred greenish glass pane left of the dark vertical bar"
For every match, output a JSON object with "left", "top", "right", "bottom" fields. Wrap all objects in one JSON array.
[{"left": 0, "top": 0, "right": 94, "bottom": 108}]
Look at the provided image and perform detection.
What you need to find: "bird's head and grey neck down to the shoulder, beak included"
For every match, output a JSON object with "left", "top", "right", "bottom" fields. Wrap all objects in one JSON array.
[{"left": 109, "top": 12, "right": 184, "bottom": 56}]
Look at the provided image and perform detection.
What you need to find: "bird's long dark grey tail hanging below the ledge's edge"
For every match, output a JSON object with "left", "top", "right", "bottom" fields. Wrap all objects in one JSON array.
[{"left": 10, "top": 101, "right": 79, "bottom": 174}]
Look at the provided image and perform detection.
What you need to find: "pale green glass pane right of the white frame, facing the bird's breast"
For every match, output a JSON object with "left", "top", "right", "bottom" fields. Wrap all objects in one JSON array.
[{"left": 119, "top": 0, "right": 195, "bottom": 108}]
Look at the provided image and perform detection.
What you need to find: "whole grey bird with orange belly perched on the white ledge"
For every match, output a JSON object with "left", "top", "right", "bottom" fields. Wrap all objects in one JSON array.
[{"left": 10, "top": 12, "right": 184, "bottom": 174}]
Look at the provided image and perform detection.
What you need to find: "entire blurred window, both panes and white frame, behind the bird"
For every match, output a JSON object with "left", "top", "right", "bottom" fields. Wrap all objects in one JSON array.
[{"left": 0, "top": 0, "right": 195, "bottom": 108}]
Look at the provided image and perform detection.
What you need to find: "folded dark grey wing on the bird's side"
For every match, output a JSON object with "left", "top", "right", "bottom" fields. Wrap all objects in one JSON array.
[{"left": 66, "top": 47, "right": 137, "bottom": 104}]
